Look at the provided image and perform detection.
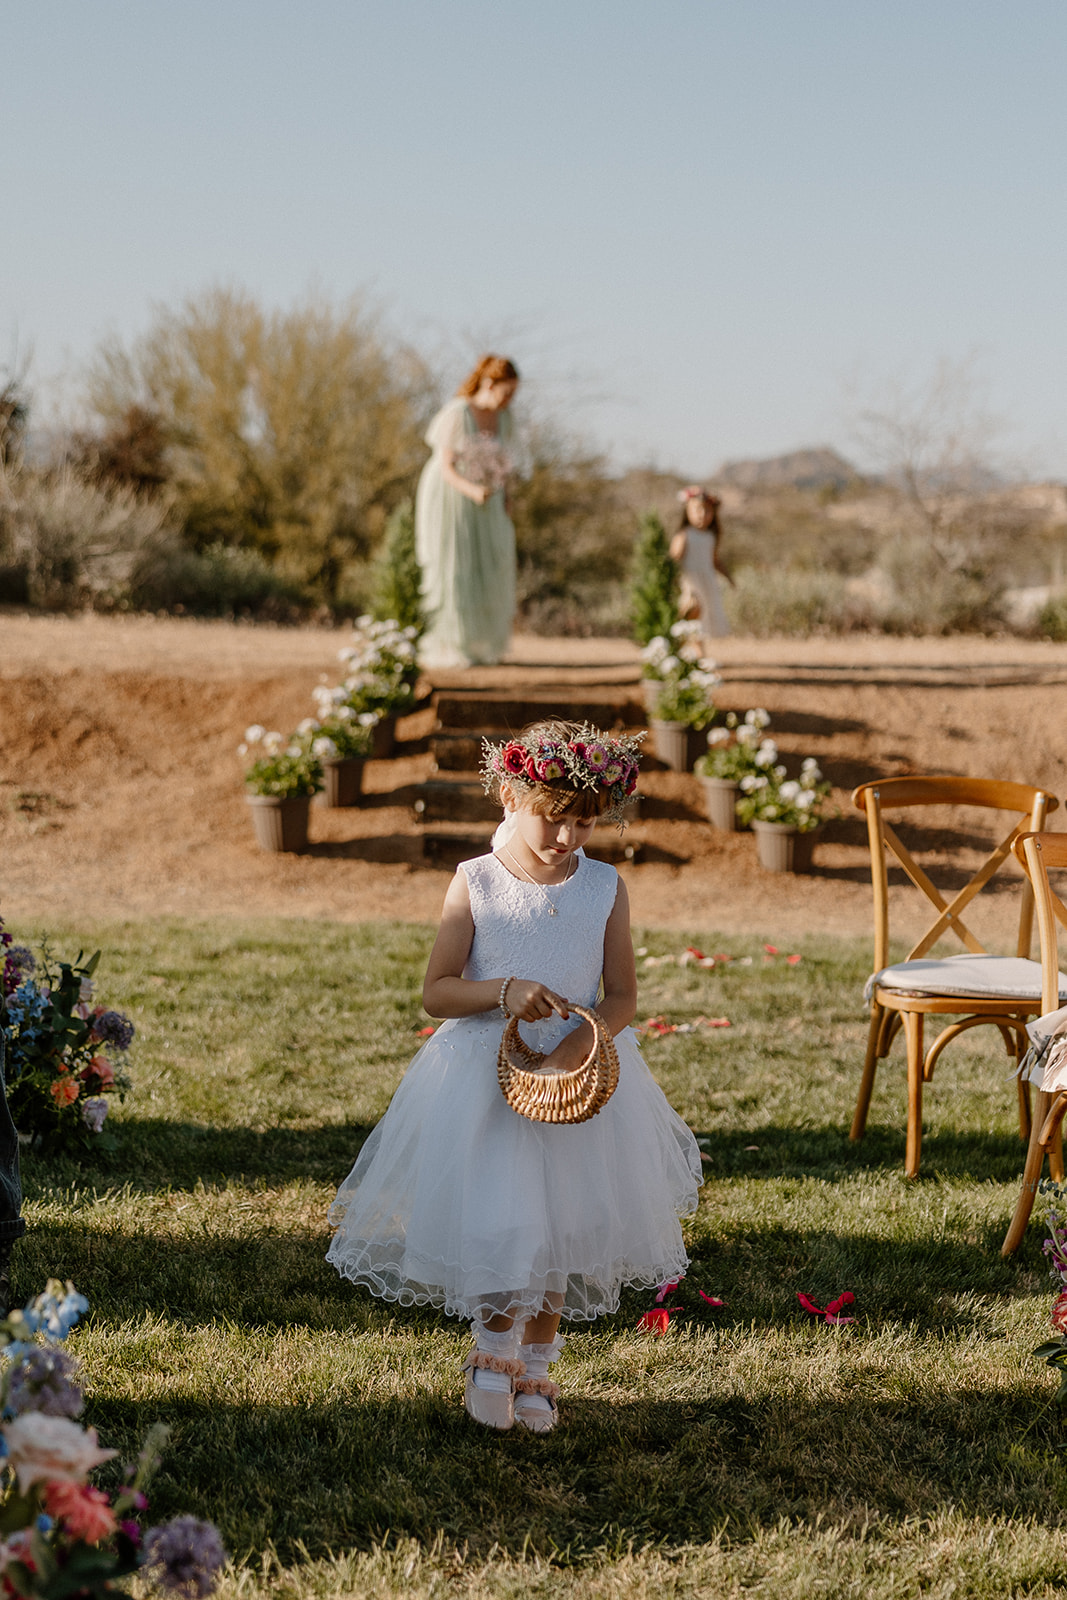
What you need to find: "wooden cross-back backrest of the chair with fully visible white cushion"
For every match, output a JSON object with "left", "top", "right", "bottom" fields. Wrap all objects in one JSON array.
[{"left": 853, "top": 778, "right": 1059, "bottom": 971}]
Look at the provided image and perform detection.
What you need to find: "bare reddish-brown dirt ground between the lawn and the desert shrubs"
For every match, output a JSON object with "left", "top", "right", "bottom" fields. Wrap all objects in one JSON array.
[{"left": 0, "top": 611, "right": 1067, "bottom": 941}]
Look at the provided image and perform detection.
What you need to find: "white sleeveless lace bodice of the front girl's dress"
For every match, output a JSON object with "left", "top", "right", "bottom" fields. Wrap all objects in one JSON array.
[{"left": 459, "top": 854, "right": 619, "bottom": 1005}]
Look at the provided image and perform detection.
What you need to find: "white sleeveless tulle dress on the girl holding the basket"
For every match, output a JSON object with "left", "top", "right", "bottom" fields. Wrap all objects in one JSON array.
[{"left": 326, "top": 854, "right": 701, "bottom": 1322}]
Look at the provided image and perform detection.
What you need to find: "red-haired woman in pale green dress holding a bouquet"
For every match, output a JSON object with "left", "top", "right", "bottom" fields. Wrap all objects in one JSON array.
[{"left": 414, "top": 355, "right": 518, "bottom": 667}]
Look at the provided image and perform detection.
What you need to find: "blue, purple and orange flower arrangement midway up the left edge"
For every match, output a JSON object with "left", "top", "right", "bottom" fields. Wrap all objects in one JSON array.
[{"left": 0, "top": 922, "right": 134, "bottom": 1149}]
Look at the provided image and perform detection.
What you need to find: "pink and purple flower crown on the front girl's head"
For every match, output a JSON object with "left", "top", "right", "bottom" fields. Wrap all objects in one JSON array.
[{"left": 482, "top": 723, "right": 645, "bottom": 827}]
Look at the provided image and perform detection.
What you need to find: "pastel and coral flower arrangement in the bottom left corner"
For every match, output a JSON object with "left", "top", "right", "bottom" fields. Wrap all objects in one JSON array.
[{"left": 0, "top": 1278, "right": 226, "bottom": 1600}]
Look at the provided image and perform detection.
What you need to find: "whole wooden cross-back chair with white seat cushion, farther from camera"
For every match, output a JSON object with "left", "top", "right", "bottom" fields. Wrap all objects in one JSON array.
[{"left": 849, "top": 778, "right": 1057, "bottom": 1178}]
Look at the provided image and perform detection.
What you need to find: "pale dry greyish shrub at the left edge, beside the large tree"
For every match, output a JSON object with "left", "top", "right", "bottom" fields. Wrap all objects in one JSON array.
[{"left": 0, "top": 464, "right": 166, "bottom": 611}]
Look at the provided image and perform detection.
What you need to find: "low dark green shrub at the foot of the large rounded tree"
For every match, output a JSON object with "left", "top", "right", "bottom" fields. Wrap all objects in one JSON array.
[{"left": 128, "top": 533, "right": 306, "bottom": 621}]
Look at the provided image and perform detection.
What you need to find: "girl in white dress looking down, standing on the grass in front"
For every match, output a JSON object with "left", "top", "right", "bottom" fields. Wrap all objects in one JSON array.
[{"left": 326, "top": 722, "right": 701, "bottom": 1434}]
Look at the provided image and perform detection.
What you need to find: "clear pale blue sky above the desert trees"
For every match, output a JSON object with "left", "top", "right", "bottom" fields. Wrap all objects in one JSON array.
[{"left": 8, "top": 0, "right": 1067, "bottom": 477}]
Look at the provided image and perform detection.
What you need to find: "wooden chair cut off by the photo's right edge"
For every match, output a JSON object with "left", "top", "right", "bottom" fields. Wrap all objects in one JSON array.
[{"left": 1000, "top": 834, "right": 1067, "bottom": 1256}]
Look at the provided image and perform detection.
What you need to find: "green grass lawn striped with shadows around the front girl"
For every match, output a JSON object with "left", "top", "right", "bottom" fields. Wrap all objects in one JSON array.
[{"left": 11, "top": 922, "right": 1067, "bottom": 1600}]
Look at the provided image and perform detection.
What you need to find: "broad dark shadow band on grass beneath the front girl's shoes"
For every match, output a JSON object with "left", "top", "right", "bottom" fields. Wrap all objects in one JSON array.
[{"left": 81, "top": 1382, "right": 1064, "bottom": 1565}]
